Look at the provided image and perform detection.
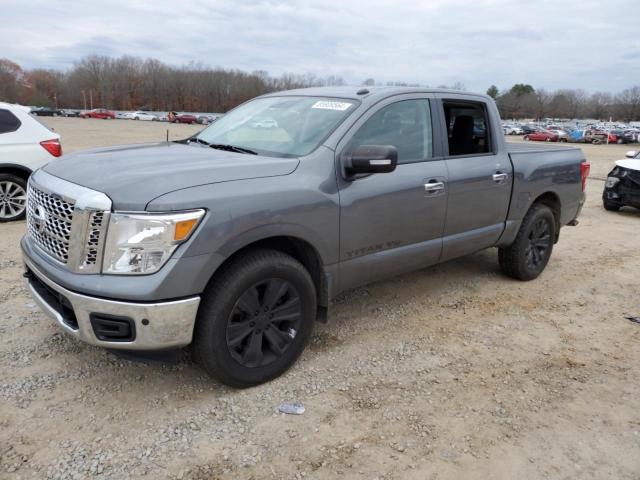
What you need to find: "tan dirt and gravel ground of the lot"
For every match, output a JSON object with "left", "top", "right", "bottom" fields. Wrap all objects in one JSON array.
[{"left": 0, "top": 119, "right": 640, "bottom": 480}]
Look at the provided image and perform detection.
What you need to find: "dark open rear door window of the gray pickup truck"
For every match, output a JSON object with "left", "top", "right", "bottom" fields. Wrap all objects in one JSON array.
[{"left": 443, "top": 100, "right": 492, "bottom": 156}]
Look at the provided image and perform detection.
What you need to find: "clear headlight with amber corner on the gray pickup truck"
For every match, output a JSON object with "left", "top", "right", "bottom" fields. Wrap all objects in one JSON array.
[{"left": 102, "top": 210, "right": 204, "bottom": 275}]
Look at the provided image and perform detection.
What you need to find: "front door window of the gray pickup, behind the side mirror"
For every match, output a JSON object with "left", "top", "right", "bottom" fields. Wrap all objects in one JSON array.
[{"left": 349, "top": 100, "right": 433, "bottom": 163}]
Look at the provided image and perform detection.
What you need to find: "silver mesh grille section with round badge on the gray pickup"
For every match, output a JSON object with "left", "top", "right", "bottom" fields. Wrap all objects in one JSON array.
[{"left": 27, "top": 183, "right": 74, "bottom": 264}]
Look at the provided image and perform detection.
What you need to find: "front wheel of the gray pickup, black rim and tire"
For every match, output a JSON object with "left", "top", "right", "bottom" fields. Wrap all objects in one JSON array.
[{"left": 192, "top": 249, "right": 316, "bottom": 388}]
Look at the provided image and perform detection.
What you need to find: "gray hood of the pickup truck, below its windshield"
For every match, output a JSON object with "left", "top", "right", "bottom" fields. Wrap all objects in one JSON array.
[{"left": 44, "top": 142, "right": 299, "bottom": 210}]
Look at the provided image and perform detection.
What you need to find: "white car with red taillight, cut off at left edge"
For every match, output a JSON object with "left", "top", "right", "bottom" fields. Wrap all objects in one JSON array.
[{"left": 0, "top": 102, "right": 62, "bottom": 222}]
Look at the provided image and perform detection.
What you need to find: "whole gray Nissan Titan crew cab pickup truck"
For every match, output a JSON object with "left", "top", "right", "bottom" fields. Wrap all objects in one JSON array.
[{"left": 22, "top": 87, "right": 589, "bottom": 387}]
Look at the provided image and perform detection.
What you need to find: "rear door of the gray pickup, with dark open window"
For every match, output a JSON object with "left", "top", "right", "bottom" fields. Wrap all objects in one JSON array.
[{"left": 437, "top": 94, "right": 513, "bottom": 260}]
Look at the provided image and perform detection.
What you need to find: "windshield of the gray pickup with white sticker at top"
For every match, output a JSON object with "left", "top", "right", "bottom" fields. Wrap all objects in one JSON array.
[{"left": 195, "top": 96, "right": 359, "bottom": 157}]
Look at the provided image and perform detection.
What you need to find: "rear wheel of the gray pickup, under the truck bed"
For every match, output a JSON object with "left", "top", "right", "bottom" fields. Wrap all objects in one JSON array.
[{"left": 498, "top": 203, "right": 556, "bottom": 281}]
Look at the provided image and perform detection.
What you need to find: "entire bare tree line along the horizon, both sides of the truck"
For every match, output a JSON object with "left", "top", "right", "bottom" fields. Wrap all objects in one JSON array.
[{"left": 0, "top": 55, "right": 640, "bottom": 121}]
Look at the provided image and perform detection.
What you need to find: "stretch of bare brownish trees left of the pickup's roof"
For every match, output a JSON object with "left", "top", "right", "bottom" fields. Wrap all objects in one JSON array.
[{"left": 0, "top": 55, "right": 345, "bottom": 112}]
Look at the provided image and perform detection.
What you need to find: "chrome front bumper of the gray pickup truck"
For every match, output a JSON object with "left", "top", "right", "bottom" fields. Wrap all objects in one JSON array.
[{"left": 23, "top": 256, "right": 200, "bottom": 350}]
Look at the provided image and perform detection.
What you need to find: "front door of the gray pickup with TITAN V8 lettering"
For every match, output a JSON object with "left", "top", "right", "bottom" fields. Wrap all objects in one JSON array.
[{"left": 336, "top": 94, "right": 447, "bottom": 289}]
